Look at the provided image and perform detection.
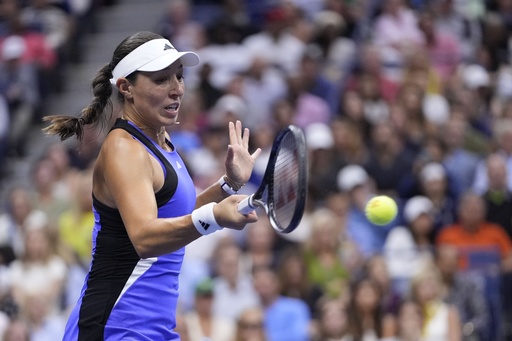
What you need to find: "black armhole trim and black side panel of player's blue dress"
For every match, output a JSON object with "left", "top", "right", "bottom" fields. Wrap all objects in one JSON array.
[{"left": 78, "top": 119, "right": 178, "bottom": 341}]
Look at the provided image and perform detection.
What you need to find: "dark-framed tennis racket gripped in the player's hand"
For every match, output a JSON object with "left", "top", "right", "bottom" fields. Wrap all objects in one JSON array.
[{"left": 238, "top": 125, "right": 307, "bottom": 233}]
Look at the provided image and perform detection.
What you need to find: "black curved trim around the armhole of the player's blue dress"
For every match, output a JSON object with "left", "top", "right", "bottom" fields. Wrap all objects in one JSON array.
[{"left": 110, "top": 118, "right": 178, "bottom": 207}]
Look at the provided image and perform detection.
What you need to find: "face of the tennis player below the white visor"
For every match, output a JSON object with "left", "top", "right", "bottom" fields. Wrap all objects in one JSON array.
[{"left": 131, "top": 60, "right": 185, "bottom": 126}]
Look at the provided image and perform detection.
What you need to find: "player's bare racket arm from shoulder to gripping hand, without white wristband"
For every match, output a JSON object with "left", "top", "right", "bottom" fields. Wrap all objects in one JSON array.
[{"left": 93, "top": 131, "right": 256, "bottom": 258}]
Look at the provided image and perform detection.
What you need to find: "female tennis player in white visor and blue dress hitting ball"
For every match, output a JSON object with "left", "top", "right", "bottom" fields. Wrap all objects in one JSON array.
[{"left": 44, "top": 32, "right": 260, "bottom": 341}]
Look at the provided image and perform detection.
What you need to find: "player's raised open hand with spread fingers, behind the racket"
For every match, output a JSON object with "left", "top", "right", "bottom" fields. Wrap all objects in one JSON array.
[{"left": 225, "top": 121, "right": 261, "bottom": 185}]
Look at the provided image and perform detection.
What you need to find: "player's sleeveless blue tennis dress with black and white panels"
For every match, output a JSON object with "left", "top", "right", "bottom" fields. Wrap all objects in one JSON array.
[{"left": 63, "top": 119, "right": 196, "bottom": 341}]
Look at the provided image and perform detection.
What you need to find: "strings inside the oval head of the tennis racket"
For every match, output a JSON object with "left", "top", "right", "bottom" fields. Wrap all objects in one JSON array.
[{"left": 269, "top": 133, "right": 300, "bottom": 228}]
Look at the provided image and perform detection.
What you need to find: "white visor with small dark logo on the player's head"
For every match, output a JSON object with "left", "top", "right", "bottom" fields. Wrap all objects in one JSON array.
[{"left": 110, "top": 39, "right": 199, "bottom": 85}]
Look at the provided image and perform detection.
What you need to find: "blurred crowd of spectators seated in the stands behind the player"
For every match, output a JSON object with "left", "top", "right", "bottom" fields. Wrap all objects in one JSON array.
[{"left": 0, "top": 0, "right": 512, "bottom": 341}]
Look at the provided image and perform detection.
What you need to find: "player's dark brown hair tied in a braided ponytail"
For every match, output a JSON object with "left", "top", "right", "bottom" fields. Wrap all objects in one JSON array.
[{"left": 43, "top": 31, "right": 162, "bottom": 141}]
